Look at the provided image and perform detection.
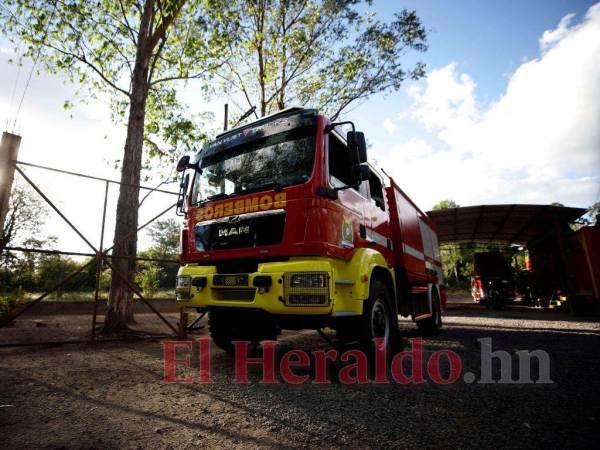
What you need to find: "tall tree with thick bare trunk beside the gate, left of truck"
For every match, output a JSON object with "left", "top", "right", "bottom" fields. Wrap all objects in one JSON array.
[{"left": 0, "top": 0, "right": 222, "bottom": 332}]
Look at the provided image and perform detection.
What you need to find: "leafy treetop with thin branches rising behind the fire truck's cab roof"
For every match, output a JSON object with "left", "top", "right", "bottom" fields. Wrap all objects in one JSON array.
[{"left": 207, "top": 0, "right": 427, "bottom": 119}]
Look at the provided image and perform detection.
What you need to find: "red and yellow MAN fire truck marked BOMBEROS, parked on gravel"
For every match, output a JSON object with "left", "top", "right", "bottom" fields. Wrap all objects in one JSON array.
[{"left": 176, "top": 108, "right": 445, "bottom": 350}]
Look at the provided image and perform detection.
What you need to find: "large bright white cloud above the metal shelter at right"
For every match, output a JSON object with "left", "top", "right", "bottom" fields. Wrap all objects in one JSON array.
[{"left": 379, "top": 4, "right": 600, "bottom": 207}]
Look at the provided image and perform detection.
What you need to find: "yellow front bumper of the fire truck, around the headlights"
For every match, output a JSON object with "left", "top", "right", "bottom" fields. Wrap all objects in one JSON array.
[{"left": 177, "top": 258, "right": 368, "bottom": 316}]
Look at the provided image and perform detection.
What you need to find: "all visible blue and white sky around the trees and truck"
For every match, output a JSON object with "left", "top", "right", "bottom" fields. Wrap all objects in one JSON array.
[{"left": 0, "top": 0, "right": 600, "bottom": 251}]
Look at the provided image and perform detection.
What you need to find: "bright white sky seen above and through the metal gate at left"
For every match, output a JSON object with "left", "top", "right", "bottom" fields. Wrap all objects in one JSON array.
[{"left": 0, "top": 50, "right": 176, "bottom": 252}]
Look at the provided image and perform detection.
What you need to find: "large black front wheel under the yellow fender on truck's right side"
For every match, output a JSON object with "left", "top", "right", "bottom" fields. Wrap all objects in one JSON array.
[{"left": 359, "top": 279, "right": 398, "bottom": 358}]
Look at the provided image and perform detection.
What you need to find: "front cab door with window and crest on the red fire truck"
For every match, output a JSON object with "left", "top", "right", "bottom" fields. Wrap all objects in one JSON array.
[{"left": 323, "top": 132, "right": 368, "bottom": 259}]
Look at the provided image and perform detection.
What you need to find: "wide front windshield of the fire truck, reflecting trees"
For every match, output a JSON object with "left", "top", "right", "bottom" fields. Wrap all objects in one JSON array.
[{"left": 192, "top": 128, "right": 315, "bottom": 204}]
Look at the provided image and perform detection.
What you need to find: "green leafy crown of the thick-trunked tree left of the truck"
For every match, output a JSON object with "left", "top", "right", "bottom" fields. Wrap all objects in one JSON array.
[{"left": 0, "top": 0, "right": 223, "bottom": 169}]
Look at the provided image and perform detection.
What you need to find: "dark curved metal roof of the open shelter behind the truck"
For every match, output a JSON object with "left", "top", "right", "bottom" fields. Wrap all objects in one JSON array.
[{"left": 427, "top": 205, "right": 585, "bottom": 244}]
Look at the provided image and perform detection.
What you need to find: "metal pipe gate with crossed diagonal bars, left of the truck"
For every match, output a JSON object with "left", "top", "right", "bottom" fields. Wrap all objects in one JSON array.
[{"left": 0, "top": 156, "right": 192, "bottom": 346}]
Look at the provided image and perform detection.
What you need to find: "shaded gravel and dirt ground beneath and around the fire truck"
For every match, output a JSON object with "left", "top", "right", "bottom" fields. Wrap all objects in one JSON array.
[{"left": 0, "top": 308, "right": 600, "bottom": 449}]
